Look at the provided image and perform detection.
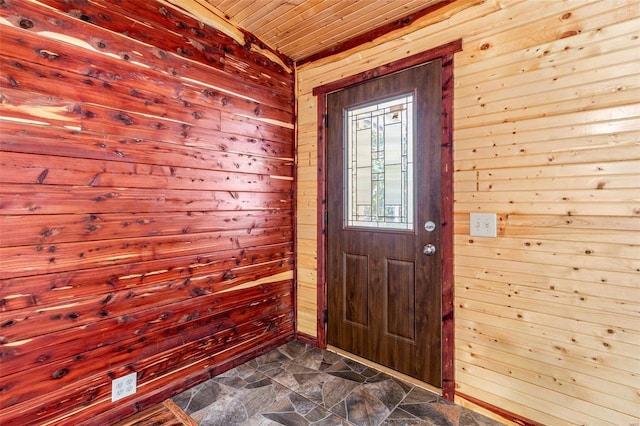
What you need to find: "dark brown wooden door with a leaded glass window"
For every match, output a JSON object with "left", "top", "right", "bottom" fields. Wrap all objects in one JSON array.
[{"left": 327, "top": 60, "right": 442, "bottom": 387}]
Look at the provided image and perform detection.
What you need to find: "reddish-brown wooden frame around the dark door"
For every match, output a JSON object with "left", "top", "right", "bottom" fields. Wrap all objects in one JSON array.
[{"left": 313, "top": 39, "right": 462, "bottom": 401}]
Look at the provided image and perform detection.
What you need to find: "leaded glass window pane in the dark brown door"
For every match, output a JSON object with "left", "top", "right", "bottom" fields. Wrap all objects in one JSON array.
[{"left": 345, "top": 94, "right": 414, "bottom": 230}]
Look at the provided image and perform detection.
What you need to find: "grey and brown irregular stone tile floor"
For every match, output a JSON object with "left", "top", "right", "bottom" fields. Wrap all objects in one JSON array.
[{"left": 173, "top": 341, "right": 501, "bottom": 426}]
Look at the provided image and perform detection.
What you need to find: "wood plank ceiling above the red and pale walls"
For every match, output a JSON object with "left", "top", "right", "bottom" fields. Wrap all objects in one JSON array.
[{"left": 202, "top": 0, "right": 445, "bottom": 61}]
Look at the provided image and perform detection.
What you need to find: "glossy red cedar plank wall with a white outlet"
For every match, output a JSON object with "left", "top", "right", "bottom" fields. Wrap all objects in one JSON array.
[{"left": 0, "top": 0, "right": 294, "bottom": 425}]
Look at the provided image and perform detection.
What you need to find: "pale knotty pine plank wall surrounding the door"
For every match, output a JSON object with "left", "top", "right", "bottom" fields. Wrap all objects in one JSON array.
[{"left": 296, "top": 0, "right": 640, "bottom": 425}]
